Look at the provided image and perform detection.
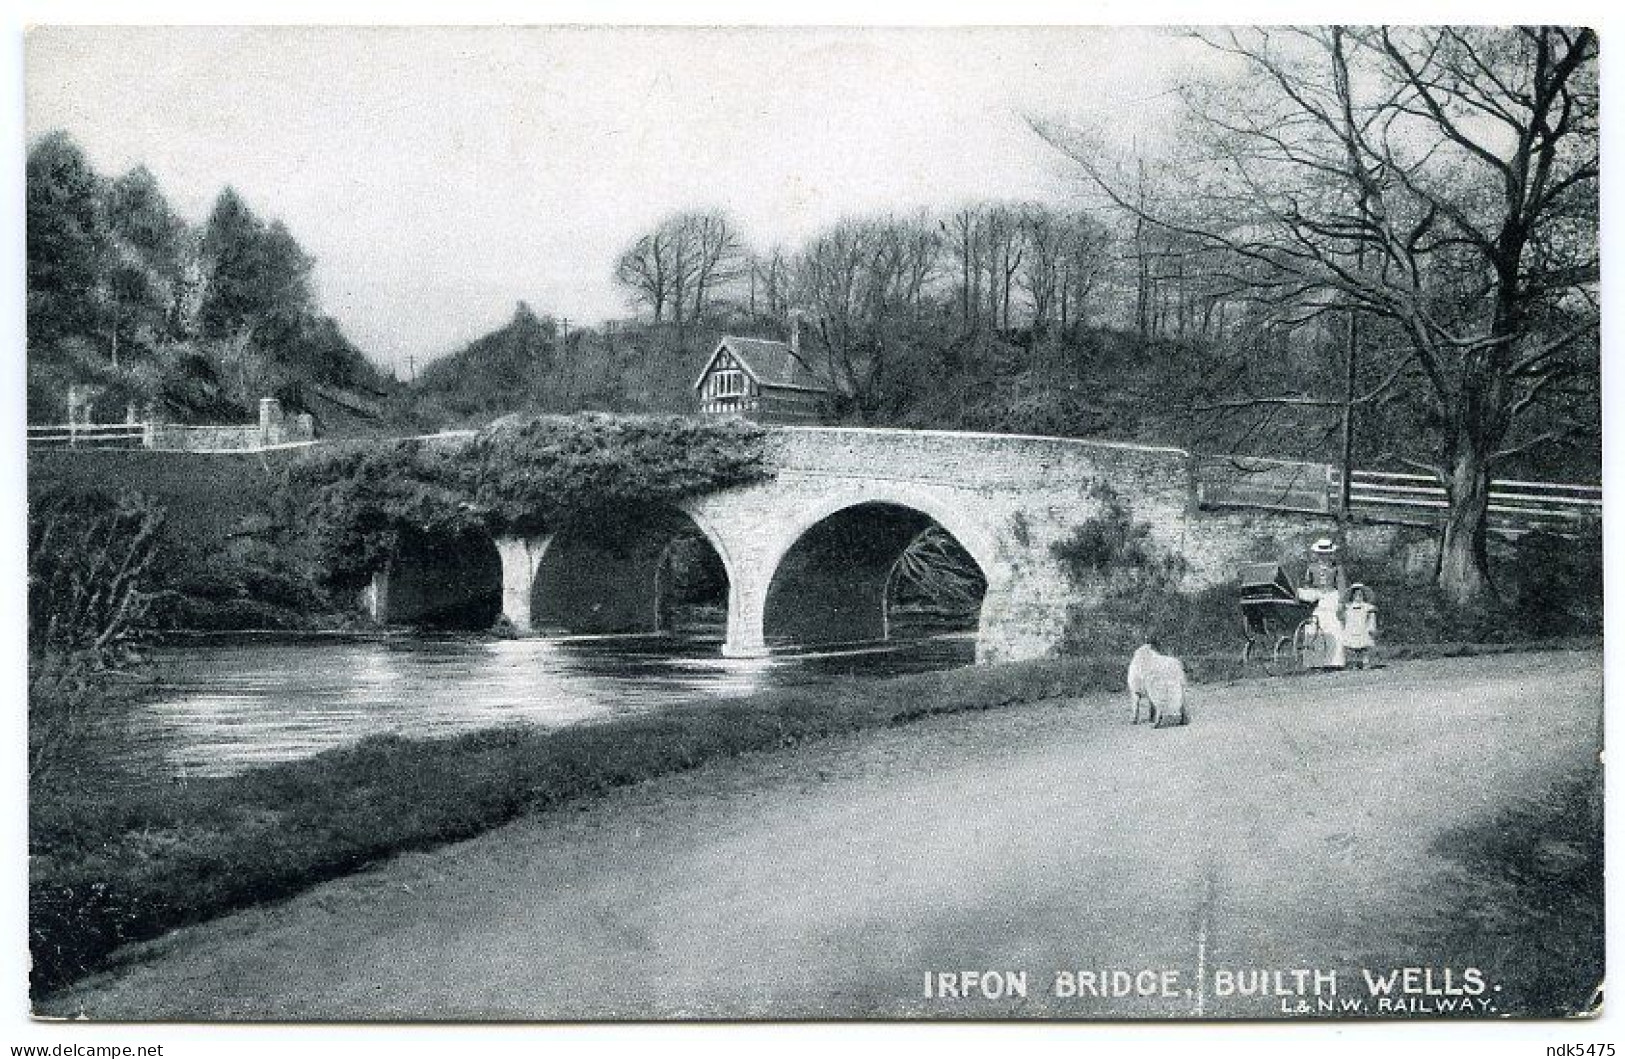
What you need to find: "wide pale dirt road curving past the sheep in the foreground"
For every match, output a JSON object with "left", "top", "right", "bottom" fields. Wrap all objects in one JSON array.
[{"left": 47, "top": 653, "right": 1602, "bottom": 1020}]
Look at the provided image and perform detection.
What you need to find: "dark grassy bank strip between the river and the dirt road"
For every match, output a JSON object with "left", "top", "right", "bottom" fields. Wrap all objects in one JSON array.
[{"left": 29, "top": 645, "right": 1599, "bottom": 997}]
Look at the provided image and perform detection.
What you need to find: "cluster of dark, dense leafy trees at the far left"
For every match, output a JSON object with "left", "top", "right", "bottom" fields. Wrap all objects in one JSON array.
[{"left": 28, "top": 132, "right": 390, "bottom": 422}]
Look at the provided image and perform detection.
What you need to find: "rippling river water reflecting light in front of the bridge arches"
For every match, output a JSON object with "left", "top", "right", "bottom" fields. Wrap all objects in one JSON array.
[{"left": 120, "top": 633, "right": 975, "bottom": 776}]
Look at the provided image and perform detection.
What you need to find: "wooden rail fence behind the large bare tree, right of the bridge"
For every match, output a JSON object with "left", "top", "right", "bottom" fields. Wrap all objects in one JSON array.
[{"left": 1196, "top": 456, "right": 1602, "bottom": 534}]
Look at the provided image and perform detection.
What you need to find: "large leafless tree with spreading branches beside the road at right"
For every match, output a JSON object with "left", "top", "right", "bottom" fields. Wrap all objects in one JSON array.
[{"left": 1040, "top": 26, "right": 1597, "bottom": 604}]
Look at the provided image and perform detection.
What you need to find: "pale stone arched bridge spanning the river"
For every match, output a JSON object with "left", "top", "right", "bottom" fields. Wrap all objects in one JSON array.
[{"left": 371, "top": 427, "right": 1410, "bottom": 661}]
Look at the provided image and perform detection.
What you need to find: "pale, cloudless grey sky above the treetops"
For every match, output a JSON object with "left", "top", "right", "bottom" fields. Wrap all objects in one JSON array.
[{"left": 24, "top": 26, "right": 1212, "bottom": 375}]
